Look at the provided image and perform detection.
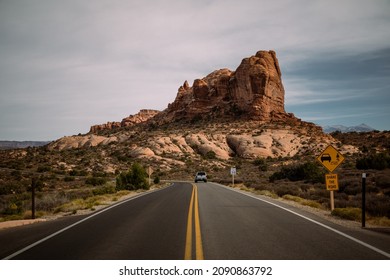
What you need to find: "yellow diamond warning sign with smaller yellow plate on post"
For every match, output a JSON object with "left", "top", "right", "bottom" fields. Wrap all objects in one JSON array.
[{"left": 317, "top": 145, "right": 345, "bottom": 211}]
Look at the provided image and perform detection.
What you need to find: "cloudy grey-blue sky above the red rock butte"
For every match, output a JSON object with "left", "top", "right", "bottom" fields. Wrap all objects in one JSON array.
[{"left": 0, "top": 0, "right": 390, "bottom": 141}]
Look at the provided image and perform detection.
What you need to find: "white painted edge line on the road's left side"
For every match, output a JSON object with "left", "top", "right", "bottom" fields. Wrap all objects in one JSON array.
[{"left": 3, "top": 184, "right": 172, "bottom": 260}]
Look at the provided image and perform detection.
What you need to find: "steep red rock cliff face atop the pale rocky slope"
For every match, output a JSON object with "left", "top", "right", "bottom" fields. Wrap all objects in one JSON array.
[{"left": 159, "top": 51, "right": 288, "bottom": 122}]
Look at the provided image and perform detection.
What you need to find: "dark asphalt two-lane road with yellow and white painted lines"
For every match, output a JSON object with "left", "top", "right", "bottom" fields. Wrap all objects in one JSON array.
[{"left": 0, "top": 183, "right": 390, "bottom": 260}]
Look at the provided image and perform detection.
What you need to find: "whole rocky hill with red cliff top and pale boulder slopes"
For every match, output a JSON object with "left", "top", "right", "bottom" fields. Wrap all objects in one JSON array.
[{"left": 49, "top": 51, "right": 356, "bottom": 166}]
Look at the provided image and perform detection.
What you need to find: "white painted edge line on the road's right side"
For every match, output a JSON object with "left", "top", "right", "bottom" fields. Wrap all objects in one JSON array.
[{"left": 212, "top": 183, "right": 390, "bottom": 259}]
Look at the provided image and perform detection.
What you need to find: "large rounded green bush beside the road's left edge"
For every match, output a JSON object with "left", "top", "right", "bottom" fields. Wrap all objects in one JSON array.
[{"left": 116, "top": 163, "right": 149, "bottom": 190}]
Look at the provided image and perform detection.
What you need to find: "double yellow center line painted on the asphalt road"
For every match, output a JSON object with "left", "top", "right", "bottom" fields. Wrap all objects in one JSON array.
[{"left": 184, "top": 184, "right": 204, "bottom": 260}]
